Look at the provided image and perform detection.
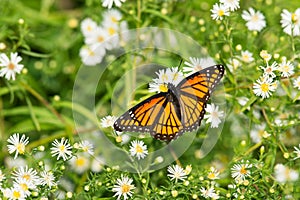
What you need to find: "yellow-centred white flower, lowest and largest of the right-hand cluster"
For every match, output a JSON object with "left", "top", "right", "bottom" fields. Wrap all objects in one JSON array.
[{"left": 253, "top": 77, "right": 277, "bottom": 99}]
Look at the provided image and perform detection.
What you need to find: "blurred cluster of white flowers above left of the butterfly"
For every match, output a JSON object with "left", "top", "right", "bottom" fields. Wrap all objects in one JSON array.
[{"left": 79, "top": 9, "right": 128, "bottom": 66}]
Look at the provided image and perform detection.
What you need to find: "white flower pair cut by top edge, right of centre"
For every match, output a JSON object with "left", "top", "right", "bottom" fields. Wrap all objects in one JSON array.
[{"left": 211, "top": 0, "right": 240, "bottom": 20}]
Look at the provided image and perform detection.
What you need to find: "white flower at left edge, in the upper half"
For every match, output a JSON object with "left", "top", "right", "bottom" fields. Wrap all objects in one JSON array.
[{"left": 0, "top": 53, "right": 24, "bottom": 80}]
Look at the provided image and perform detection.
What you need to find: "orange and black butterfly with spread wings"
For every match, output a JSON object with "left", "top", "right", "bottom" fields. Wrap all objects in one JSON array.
[{"left": 114, "top": 65, "right": 225, "bottom": 142}]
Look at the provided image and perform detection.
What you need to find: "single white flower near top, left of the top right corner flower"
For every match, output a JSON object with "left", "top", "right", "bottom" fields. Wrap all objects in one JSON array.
[{"left": 242, "top": 7, "right": 266, "bottom": 31}]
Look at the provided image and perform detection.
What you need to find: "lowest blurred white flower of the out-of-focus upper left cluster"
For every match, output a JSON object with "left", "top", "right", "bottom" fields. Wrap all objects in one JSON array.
[{"left": 79, "top": 45, "right": 105, "bottom": 66}]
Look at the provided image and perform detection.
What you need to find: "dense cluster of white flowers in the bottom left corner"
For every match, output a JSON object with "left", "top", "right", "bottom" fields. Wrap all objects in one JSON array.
[{"left": 0, "top": 166, "right": 57, "bottom": 199}]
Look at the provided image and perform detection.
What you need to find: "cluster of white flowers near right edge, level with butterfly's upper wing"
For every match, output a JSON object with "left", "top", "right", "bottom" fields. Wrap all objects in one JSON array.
[{"left": 253, "top": 50, "right": 296, "bottom": 99}]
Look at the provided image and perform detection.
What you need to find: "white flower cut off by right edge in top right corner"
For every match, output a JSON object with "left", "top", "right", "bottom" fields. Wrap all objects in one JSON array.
[{"left": 280, "top": 8, "right": 300, "bottom": 36}]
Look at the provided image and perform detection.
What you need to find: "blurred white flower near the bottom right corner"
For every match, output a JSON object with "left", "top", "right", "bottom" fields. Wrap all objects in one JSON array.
[{"left": 274, "top": 164, "right": 299, "bottom": 183}]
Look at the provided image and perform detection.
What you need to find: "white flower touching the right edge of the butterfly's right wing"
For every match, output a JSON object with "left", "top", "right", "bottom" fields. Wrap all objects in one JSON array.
[{"left": 204, "top": 103, "right": 224, "bottom": 128}]
